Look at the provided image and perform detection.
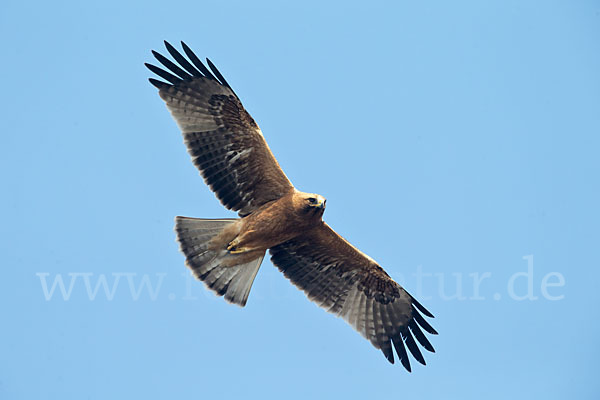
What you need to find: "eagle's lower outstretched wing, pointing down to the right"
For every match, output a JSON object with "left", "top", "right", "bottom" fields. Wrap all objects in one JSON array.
[{"left": 270, "top": 223, "right": 437, "bottom": 371}]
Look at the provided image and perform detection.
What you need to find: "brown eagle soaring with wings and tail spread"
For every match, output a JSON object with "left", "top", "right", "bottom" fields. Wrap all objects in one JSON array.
[{"left": 145, "top": 41, "right": 437, "bottom": 372}]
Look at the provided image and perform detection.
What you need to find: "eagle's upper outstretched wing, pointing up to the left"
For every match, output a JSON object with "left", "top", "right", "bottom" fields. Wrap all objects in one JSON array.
[{"left": 146, "top": 41, "right": 293, "bottom": 216}]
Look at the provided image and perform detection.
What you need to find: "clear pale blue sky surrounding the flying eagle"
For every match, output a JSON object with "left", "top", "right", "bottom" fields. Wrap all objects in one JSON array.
[{"left": 0, "top": 1, "right": 600, "bottom": 399}]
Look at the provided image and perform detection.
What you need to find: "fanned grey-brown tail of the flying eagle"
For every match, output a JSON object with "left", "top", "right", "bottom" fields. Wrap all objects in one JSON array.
[{"left": 175, "top": 217, "right": 264, "bottom": 307}]
